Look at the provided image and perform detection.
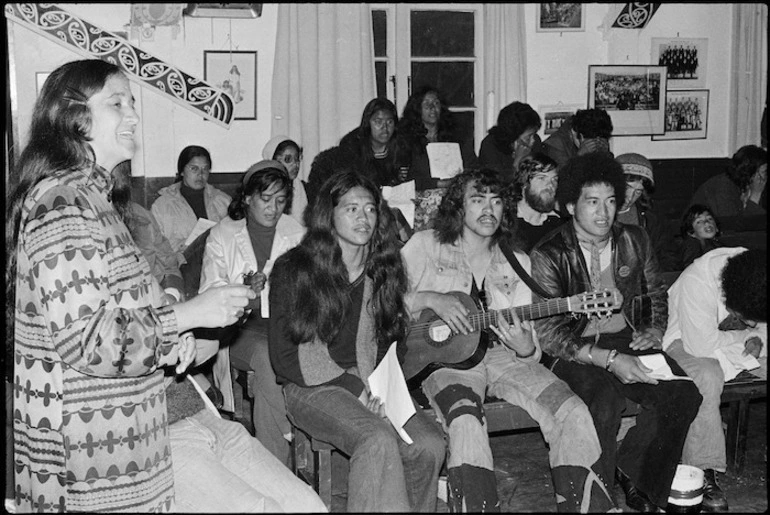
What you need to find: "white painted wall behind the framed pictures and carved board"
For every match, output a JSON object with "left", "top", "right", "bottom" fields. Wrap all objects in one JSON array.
[{"left": 9, "top": 3, "right": 752, "bottom": 177}]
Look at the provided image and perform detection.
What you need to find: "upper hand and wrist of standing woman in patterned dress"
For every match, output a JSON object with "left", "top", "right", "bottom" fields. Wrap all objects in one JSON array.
[{"left": 172, "top": 284, "right": 257, "bottom": 333}]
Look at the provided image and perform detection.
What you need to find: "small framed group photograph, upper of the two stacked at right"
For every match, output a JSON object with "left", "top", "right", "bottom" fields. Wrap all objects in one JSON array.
[{"left": 650, "top": 38, "right": 708, "bottom": 89}]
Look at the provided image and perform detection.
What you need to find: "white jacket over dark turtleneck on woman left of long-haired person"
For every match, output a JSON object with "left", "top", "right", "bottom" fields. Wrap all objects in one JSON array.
[{"left": 198, "top": 215, "right": 305, "bottom": 411}]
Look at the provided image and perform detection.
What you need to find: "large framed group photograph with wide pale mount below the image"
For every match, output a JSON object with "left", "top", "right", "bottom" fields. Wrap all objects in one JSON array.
[{"left": 588, "top": 65, "right": 666, "bottom": 136}]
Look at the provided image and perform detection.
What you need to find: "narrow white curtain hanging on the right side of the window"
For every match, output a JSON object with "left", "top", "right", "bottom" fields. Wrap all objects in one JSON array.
[{"left": 483, "top": 3, "right": 527, "bottom": 129}]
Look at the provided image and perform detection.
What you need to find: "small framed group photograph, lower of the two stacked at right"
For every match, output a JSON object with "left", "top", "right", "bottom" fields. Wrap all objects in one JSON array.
[{"left": 652, "top": 89, "right": 709, "bottom": 141}]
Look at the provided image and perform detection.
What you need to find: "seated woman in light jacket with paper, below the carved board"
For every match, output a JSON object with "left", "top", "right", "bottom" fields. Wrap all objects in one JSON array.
[{"left": 150, "top": 145, "right": 232, "bottom": 253}]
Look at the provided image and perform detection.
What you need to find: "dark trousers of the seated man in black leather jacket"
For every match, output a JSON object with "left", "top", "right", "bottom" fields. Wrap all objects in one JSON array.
[{"left": 551, "top": 329, "right": 702, "bottom": 507}]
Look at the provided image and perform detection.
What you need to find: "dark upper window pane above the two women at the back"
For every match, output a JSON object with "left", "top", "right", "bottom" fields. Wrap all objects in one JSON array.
[{"left": 412, "top": 11, "right": 474, "bottom": 57}]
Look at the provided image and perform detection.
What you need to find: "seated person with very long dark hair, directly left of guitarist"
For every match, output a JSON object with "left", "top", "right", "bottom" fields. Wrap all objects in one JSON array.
[{"left": 269, "top": 171, "right": 445, "bottom": 512}]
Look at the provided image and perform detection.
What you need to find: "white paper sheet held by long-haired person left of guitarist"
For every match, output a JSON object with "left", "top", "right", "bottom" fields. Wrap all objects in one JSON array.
[{"left": 369, "top": 342, "right": 416, "bottom": 444}]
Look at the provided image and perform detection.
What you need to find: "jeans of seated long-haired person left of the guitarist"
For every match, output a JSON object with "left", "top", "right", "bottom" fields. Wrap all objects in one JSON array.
[{"left": 284, "top": 383, "right": 446, "bottom": 513}]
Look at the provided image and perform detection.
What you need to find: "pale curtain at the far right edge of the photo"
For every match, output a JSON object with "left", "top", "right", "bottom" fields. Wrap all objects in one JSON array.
[{"left": 729, "top": 4, "right": 767, "bottom": 151}]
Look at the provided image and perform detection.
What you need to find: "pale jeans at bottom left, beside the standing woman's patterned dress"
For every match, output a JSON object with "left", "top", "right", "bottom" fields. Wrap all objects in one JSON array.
[{"left": 169, "top": 409, "right": 328, "bottom": 513}]
